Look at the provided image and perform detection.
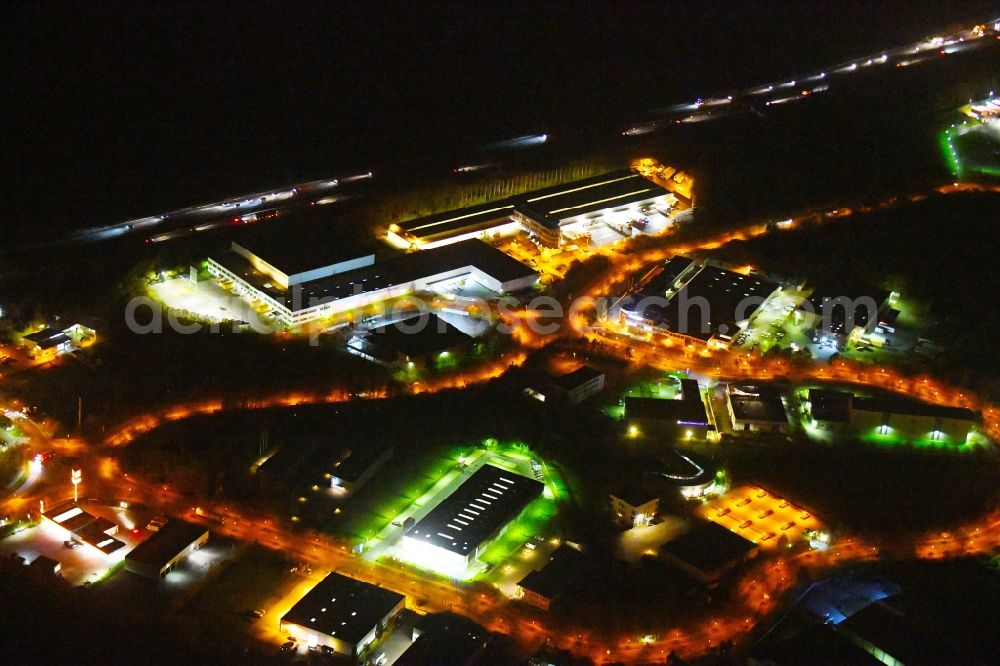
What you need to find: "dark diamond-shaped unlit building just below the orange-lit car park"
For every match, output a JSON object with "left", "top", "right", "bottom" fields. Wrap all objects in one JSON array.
[{"left": 660, "top": 521, "right": 760, "bottom": 585}]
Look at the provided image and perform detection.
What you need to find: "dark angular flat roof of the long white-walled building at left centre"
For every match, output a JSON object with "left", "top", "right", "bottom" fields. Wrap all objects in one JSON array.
[{"left": 212, "top": 238, "right": 537, "bottom": 312}]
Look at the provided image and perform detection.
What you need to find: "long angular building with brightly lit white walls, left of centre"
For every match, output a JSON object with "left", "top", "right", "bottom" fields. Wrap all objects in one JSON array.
[{"left": 207, "top": 239, "right": 538, "bottom": 326}]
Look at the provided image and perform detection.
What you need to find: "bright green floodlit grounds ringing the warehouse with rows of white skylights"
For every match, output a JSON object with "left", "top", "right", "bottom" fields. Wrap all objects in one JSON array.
[{"left": 358, "top": 438, "right": 567, "bottom": 582}]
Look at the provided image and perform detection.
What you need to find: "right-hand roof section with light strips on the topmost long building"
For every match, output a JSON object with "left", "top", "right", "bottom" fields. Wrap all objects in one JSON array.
[{"left": 511, "top": 169, "right": 669, "bottom": 229}]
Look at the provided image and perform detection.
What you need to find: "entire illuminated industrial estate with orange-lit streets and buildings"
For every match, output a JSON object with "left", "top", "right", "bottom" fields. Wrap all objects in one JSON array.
[{"left": 0, "top": 9, "right": 1000, "bottom": 666}]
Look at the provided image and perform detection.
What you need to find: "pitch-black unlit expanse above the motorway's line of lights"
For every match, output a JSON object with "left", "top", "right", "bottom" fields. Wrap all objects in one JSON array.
[{"left": 0, "top": 0, "right": 997, "bottom": 225}]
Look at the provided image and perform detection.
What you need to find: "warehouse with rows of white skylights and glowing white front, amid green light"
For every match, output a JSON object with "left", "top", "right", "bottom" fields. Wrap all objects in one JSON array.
[{"left": 403, "top": 465, "right": 544, "bottom": 573}]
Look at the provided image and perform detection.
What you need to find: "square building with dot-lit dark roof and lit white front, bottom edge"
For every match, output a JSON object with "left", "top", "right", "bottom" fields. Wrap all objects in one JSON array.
[{"left": 280, "top": 573, "right": 406, "bottom": 661}]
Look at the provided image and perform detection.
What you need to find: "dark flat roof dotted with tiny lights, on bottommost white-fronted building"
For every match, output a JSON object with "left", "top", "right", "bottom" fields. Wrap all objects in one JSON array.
[{"left": 281, "top": 573, "right": 404, "bottom": 645}]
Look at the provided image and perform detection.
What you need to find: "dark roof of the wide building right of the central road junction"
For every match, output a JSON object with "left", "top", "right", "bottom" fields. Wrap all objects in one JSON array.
[{"left": 625, "top": 257, "right": 778, "bottom": 341}]
